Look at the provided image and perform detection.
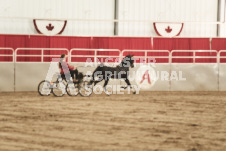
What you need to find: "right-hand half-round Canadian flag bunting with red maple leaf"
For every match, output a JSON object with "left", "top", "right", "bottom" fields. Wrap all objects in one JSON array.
[{"left": 153, "top": 22, "right": 184, "bottom": 37}]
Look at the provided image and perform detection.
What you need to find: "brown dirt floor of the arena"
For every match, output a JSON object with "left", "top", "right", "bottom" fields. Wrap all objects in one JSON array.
[{"left": 0, "top": 92, "right": 226, "bottom": 151}]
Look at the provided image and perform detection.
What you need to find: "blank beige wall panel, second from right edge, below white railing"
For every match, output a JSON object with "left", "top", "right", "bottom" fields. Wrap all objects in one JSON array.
[{"left": 170, "top": 63, "right": 219, "bottom": 91}]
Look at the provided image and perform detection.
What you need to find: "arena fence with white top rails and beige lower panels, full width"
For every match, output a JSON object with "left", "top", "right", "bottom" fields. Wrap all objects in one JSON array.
[{"left": 0, "top": 48, "right": 226, "bottom": 91}]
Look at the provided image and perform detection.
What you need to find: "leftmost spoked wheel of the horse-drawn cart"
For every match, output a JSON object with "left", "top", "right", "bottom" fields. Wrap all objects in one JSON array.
[{"left": 38, "top": 80, "right": 51, "bottom": 96}]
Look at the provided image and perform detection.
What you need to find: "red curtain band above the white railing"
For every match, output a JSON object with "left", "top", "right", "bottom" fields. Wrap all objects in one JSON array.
[{"left": 0, "top": 35, "right": 226, "bottom": 51}]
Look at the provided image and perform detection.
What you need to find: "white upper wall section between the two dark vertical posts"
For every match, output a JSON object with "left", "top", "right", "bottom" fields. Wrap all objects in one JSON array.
[{"left": 118, "top": 0, "right": 218, "bottom": 37}]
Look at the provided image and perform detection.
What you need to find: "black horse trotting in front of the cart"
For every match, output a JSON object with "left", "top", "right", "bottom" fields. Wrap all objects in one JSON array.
[{"left": 90, "top": 55, "right": 136, "bottom": 94}]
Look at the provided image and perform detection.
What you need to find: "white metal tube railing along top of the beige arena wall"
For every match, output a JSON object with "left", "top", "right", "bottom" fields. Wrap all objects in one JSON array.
[{"left": 0, "top": 48, "right": 226, "bottom": 63}]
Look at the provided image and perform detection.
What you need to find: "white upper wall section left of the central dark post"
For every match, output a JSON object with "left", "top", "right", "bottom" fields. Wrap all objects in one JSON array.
[{"left": 0, "top": 0, "right": 114, "bottom": 36}]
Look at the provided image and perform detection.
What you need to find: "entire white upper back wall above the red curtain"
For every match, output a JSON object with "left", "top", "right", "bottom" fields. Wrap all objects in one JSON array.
[{"left": 0, "top": 0, "right": 222, "bottom": 37}]
